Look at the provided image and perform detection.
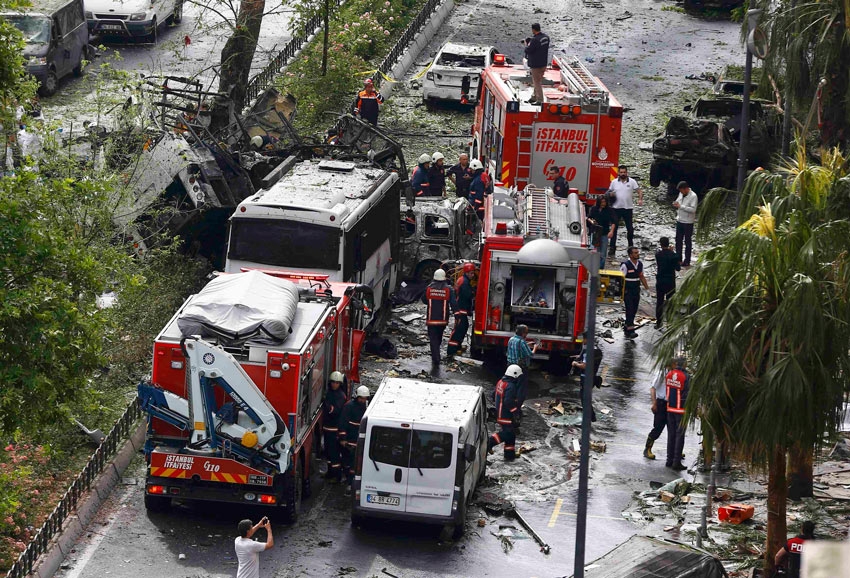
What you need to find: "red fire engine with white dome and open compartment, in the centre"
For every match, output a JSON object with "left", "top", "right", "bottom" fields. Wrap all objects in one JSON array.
[{"left": 472, "top": 185, "right": 588, "bottom": 357}]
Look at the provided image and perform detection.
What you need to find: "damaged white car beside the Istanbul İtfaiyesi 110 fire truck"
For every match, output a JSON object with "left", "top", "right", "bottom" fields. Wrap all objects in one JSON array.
[{"left": 422, "top": 42, "right": 496, "bottom": 104}]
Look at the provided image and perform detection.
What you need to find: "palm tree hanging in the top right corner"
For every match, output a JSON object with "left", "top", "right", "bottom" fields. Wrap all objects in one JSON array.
[{"left": 750, "top": 0, "right": 850, "bottom": 146}]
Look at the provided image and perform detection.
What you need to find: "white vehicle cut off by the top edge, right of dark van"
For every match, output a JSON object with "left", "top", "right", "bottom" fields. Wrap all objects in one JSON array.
[{"left": 85, "top": 0, "right": 183, "bottom": 43}]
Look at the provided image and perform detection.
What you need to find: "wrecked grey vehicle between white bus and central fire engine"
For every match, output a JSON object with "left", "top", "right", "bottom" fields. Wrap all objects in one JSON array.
[{"left": 399, "top": 198, "right": 481, "bottom": 281}]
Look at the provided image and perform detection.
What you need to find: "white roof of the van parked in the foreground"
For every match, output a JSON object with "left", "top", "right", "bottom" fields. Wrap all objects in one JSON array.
[{"left": 367, "top": 377, "right": 482, "bottom": 427}]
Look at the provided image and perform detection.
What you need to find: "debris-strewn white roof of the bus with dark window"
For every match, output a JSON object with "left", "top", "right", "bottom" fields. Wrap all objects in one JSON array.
[{"left": 234, "top": 159, "right": 398, "bottom": 223}]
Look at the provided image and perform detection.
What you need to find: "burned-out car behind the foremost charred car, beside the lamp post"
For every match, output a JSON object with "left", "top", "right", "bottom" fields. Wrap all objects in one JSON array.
[{"left": 685, "top": 97, "right": 782, "bottom": 169}]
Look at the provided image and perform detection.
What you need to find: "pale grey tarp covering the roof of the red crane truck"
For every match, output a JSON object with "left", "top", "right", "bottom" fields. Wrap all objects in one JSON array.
[{"left": 177, "top": 271, "right": 298, "bottom": 345}]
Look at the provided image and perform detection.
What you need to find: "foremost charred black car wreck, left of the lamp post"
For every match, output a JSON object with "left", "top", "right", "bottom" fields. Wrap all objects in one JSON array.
[{"left": 649, "top": 116, "right": 738, "bottom": 195}]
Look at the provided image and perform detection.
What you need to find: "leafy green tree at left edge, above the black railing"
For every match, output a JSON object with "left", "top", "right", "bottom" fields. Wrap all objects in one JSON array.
[{"left": 0, "top": 169, "right": 129, "bottom": 433}]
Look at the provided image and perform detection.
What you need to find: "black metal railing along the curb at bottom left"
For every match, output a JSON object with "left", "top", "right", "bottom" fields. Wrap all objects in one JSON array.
[{"left": 6, "top": 398, "right": 142, "bottom": 578}]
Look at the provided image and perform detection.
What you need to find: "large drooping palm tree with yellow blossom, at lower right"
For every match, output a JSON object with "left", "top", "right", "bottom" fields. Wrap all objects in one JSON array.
[{"left": 657, "top": 146, "right": 850, "bottom": 571}]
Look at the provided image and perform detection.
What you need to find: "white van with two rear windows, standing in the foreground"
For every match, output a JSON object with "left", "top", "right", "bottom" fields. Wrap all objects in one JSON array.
[{"left": 351, "top": 378, "right": 488, "bottom": 538}]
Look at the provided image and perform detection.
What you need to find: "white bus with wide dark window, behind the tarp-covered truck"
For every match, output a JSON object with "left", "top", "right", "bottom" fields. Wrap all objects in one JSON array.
[{"left": 225, "top": 156, "right": 403, "bottom": 310}]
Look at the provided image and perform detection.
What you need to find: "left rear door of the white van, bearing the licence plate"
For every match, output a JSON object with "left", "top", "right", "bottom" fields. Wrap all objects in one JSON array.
[{"left": 360, "top": 418, "right": 412, "bottom": 512}]
